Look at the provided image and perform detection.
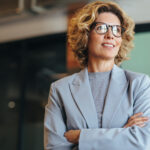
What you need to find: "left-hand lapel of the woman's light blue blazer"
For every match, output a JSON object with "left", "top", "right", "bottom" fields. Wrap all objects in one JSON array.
[{"left": 70, "top": 68, "right": 98, "bottom": 128}]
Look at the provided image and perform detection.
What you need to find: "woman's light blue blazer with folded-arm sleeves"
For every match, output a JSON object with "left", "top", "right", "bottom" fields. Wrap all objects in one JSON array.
[{"left": 44, "top": 65, "right": 150, "bottom": 150}]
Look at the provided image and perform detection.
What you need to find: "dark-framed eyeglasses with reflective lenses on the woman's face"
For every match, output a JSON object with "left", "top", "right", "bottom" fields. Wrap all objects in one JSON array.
[{"left": 92, "top": 22, "right": 125, "bottom": 37}]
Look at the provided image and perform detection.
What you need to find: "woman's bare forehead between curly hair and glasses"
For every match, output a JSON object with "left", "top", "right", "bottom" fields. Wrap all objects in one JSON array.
[{"left": 95, "top": 12, "right": 121, "bottom": 25}]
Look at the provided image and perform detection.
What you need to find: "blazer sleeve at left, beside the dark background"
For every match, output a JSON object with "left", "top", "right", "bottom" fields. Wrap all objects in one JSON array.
[{"left": 44, "top": 84, "right": 73, "bottom": 150}]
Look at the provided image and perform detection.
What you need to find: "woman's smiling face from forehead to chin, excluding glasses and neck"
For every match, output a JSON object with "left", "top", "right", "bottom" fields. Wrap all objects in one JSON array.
[{"left": 88, "top": 12, "right": 122, "bottom": 61}]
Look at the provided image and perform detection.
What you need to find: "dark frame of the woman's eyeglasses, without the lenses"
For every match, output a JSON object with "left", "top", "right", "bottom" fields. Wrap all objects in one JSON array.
[{"left": 92, "top": 22, "right": 125, "bottom": 38}]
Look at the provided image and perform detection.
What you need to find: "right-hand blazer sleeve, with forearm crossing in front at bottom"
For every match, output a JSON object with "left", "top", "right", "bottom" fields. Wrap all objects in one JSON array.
[{"left": 79, "top": 75, "right": 150, "bottom": 150}]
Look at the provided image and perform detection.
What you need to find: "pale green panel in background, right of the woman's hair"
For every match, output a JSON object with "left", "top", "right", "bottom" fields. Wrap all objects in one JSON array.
[{"left": 122, "top": 32, "right": 150, "bottom": 76}]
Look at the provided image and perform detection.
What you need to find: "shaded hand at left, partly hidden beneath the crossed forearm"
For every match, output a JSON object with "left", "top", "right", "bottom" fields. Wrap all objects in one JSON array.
[{"left": 64, "top": 130, "right": 80, "bottom": 144}]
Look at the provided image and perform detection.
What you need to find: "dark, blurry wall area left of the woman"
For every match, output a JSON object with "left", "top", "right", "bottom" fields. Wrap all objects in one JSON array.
[{"left": 0, "top": 33, "right": 66, "bottom": 150}]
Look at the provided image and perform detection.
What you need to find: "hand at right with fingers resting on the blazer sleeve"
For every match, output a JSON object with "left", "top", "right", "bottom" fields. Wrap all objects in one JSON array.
[{"left": 124, "top": 112, "right": 149, "bottom": 128}]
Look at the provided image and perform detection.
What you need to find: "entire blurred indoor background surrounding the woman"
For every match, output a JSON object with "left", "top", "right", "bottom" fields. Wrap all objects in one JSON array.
[{"left": 0, "top": 0, "right": 150, "bottom": 150}]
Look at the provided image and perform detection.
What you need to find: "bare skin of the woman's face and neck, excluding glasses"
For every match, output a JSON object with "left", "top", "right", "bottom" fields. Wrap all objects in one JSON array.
[{"left": 88, "top": 12, "right": 122, "bottom": 72}]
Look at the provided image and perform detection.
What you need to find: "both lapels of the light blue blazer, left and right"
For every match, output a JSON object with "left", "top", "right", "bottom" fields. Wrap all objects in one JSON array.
[{"left": 70, "top": 65, "right": 128, "bottom": 128}]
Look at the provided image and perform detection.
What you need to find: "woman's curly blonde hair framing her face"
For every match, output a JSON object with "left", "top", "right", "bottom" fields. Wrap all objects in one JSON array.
[{"left": 68, "top": 1, "right": 135, "bottom": 67}]
